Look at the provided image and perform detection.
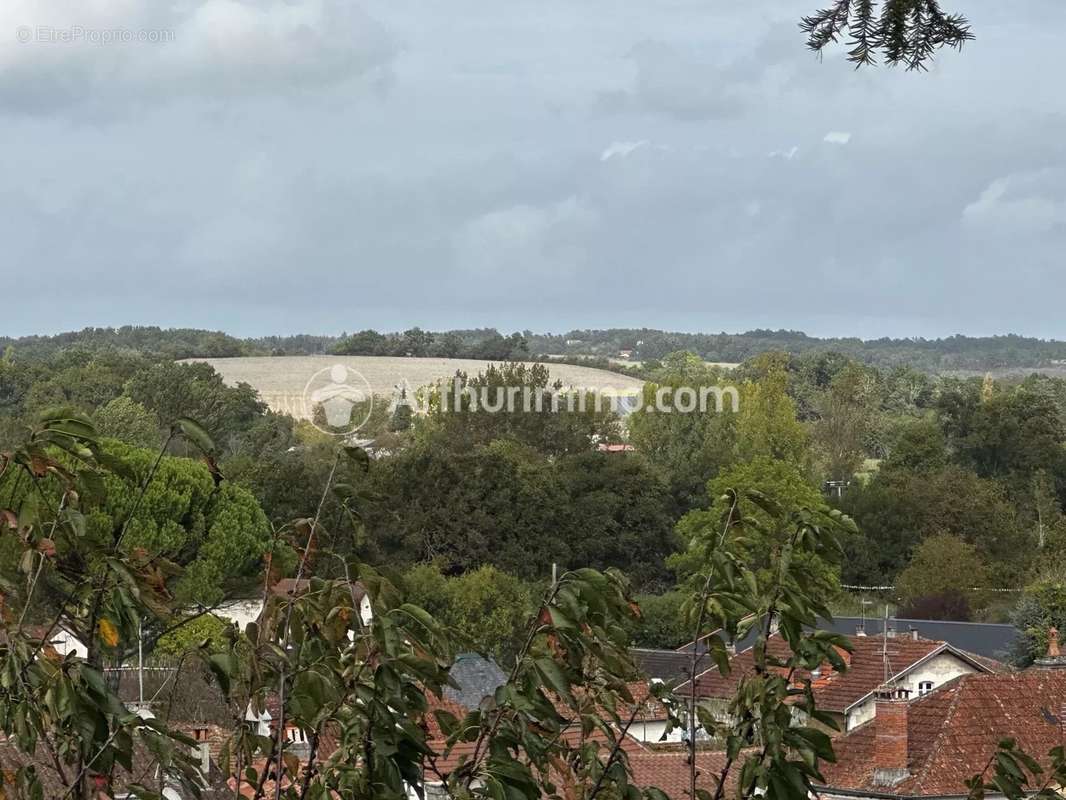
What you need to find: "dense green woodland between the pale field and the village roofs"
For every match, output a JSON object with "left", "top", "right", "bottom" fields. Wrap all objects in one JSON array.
[{"left": 0, "top": 329, "right": 1066, "bottom": 665}]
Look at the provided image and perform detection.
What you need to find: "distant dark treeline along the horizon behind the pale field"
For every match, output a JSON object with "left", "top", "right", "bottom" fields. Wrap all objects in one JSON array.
[{"left": 6, "top": 325, "right": 1066, "bottom": 372}]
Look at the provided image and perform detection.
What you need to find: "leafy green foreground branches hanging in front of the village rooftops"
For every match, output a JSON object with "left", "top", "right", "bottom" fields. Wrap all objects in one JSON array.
[{"left": 6, "top": 415, "right": 1066, "bottom": 800}]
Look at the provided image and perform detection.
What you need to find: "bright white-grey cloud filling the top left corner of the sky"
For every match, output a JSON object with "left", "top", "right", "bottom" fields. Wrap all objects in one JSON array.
[{"left": 0, "top": 0, "right": 397, "bottom": 117}]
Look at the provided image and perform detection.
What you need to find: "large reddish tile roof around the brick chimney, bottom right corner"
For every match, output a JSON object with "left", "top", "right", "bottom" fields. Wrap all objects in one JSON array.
[{"left": 823, "top": 670, "right": 1066, "bottom": 797}]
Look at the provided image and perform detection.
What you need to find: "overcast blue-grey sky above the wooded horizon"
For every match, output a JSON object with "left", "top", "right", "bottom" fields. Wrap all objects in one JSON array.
[{"left": 0, "top": 0, "right": 1066, "bottom": 338}]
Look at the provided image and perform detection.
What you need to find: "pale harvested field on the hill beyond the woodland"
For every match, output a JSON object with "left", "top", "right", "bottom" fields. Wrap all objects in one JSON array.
[{"left": 188, "top": 355, "right": 644, "bottom": 418}]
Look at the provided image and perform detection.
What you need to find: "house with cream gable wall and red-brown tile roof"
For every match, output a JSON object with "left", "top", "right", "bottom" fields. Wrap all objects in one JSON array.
[{"left": 678, "top": 631, "right": 1003, "bottom": 731}]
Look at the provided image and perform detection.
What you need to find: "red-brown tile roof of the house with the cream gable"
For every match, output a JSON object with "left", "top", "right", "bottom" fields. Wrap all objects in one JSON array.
[{"left": 678, "top": 636, "right": 990, "bottom": 713}]
